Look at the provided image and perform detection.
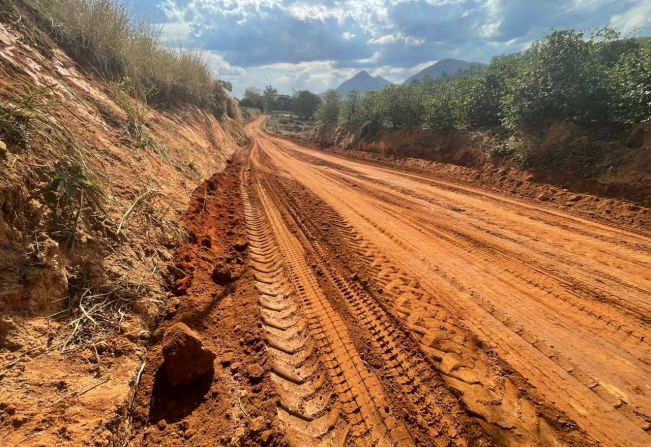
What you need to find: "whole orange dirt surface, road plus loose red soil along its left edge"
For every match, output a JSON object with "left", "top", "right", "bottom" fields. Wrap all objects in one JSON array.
[{"left": 125, "top": 119, "right": 651, "bottom": 447}]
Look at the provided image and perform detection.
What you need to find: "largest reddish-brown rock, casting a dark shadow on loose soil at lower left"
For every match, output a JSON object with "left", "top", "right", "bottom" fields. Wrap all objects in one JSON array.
[{"left": 163, "top": 323, "right": 216, "bottom": 386}]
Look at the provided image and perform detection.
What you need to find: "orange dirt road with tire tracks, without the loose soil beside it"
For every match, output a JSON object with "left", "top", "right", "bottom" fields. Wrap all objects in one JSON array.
[{"left": 242, "top": 120, "right": 651, "bottom": 446}]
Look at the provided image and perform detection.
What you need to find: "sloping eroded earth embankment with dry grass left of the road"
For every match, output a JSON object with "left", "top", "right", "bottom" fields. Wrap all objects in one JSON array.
[{"left": 0, "top": 9, "right": 245, "bottom": 446}]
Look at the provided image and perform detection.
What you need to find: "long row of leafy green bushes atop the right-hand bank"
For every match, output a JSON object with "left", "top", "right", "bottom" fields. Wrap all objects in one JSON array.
[{"left": 317, "top": 28, "right": 651, "bottom": 168}]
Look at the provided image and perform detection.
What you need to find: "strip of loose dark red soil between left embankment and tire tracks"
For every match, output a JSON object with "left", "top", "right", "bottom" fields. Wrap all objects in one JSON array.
[{"left": 131, "top": 154, "right": 284, "bottom": 447}]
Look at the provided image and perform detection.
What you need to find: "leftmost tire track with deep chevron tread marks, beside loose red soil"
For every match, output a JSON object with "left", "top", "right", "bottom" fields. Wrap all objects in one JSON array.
[{"left": 242, "top": 170, "right": 349, "bottom": 447}]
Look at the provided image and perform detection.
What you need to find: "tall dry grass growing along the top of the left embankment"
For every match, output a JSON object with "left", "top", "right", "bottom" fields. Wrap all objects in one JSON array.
[{"left": 27, "top": 0, "right": 230, "bottom": 112}]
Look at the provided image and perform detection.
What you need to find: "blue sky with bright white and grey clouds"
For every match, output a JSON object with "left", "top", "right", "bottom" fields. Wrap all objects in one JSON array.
[{"left": 131, "top": 0, "right": 651, "bottom": 97}]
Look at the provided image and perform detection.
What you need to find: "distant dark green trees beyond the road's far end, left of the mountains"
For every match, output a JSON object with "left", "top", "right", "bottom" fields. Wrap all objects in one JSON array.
[{"left": 240, "top": 85, "right": 321, "bottom": 119}]
